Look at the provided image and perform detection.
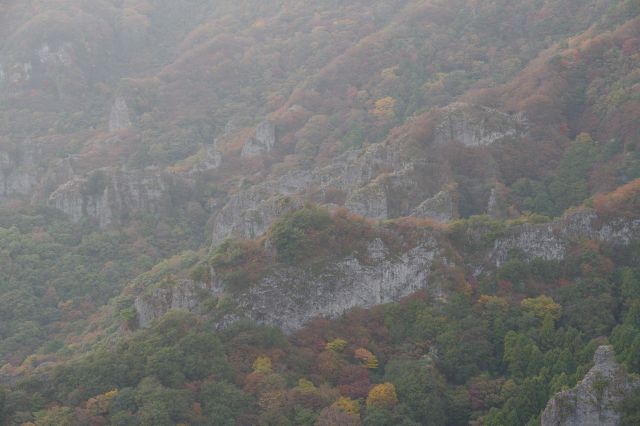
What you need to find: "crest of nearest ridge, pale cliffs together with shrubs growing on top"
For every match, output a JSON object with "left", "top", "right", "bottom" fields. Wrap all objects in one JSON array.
[{"left": 135, "top": 181, "right": 640, "bottom": 332}]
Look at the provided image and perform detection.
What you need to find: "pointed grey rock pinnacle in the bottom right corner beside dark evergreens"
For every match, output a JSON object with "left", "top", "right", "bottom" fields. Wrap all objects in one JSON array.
[{"left": 541, "top": 346, "right": 640, "bottom": 426}]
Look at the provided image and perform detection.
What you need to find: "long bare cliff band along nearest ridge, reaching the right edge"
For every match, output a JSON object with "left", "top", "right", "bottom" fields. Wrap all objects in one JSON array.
[{"left": 136, "top": 207, "right": 640, "bottom": 331}]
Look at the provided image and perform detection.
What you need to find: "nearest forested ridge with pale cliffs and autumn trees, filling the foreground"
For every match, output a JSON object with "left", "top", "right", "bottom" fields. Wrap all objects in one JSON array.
[{"left": 1, "top": 181, "right": 640, "bottom": 426}]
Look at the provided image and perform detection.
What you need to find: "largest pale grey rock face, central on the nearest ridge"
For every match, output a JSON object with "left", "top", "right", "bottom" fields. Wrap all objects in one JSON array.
[{"left": 236, "top": 239, "right": 439, "bottom": 332}]
